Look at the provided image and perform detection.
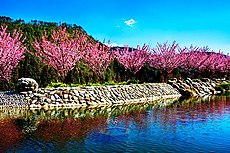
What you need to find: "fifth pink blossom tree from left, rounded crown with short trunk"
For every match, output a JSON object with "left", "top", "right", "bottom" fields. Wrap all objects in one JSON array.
[{"left": 148, "top": 41, "right": 184, "bottom": 81}]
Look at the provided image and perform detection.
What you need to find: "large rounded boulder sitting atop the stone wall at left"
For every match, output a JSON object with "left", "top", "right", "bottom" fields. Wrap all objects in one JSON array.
[{"left": 17, "top": 78, "right": 38, "bottom": 92}]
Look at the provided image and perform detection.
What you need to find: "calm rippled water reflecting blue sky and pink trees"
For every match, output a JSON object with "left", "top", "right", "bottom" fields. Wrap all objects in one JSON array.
[{"left": 0, "top": 96, "right": 230, "bottom": 153}]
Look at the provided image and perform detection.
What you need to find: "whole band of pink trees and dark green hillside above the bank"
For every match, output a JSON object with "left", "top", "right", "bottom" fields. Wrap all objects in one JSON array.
[{"left": 0, "top": 17, "right": 230, "bottom": 90}]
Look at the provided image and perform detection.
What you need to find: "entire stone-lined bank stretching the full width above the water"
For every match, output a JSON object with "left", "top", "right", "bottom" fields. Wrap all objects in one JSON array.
[{"left": 0, "top": 78, "right": 230, "bottom": 109}]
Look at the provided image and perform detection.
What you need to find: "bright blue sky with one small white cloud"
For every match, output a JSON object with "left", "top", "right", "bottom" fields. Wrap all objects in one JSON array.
[{"left": 0, "top": 0, "right": 230, "bottom": 53}]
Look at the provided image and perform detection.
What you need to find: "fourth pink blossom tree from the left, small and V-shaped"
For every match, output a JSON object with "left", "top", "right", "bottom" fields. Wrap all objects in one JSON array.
[{"left": 113, "top": 45, "right": 149, "bottom": 74}]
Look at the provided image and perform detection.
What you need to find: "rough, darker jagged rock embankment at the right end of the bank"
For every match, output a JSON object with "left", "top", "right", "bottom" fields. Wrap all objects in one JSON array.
[{"left": 168, "top": 78, "right": 230, "bottom": 97}]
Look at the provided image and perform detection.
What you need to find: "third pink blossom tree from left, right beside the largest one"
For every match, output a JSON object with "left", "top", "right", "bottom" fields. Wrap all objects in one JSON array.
[{"left": 82, "top": 41, "right": 114, "bottom": 76}]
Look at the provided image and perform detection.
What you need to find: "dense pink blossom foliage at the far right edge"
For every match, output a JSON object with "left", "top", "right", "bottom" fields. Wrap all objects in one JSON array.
[{"left": 180, "top": 46, "right": 230, "bottom": 77}]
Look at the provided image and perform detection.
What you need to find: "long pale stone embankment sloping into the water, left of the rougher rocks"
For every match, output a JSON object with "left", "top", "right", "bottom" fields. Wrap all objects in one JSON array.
[{"left": 20, "top": 83, "right": 181, "bottom": 108}]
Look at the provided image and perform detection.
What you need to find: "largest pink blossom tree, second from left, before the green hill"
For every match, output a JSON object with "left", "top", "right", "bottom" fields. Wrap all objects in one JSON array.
[{"left": 29, "top": 26, "right": 87, "bottom": 81}]
